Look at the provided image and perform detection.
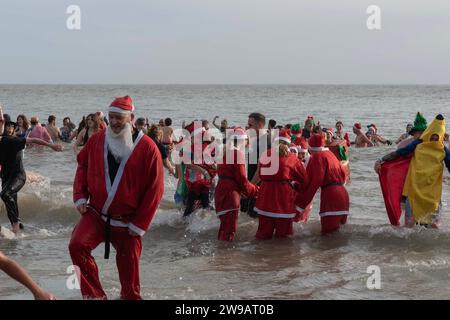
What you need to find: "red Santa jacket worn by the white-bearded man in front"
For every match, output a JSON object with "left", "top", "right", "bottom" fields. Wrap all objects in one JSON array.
[{"left": 73, "top": 131, "right": 164, "bottom": 236}]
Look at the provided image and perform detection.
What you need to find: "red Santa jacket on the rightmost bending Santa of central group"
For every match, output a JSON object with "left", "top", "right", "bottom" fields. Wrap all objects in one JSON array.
[{"left": 295, "top": 148, "right": 350, "bottom": 217}]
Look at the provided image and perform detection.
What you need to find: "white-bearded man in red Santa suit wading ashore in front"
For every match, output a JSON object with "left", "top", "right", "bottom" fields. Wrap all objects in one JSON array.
[{"left": 69, "top": 96, "right": 164, "bottom": 299}]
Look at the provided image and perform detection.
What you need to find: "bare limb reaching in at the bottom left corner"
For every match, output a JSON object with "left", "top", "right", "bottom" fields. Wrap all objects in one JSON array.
[{"left": 0, "top": 252, "right": 56, "bottom": 300}]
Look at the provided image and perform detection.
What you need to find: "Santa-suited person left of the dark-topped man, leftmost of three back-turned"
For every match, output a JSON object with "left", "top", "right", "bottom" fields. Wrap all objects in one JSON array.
[{"left": 214, "top": 128, "right": 258, "bottom": 241}]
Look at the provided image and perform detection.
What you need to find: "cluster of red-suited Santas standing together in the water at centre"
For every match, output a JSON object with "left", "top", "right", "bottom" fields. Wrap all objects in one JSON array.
[{"left": 179, "top": 121, "right": 349, "bottom": 241}]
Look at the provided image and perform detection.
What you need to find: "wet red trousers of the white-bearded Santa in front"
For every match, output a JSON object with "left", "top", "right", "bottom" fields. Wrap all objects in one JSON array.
[{"left": 69, "top": 211, "right": 142, "bottom": 300}]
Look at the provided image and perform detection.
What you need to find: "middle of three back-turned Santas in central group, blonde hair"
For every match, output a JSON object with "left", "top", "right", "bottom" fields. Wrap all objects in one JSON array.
[{"left": 255, "top": 130, "right": 308, "bottom": 240}]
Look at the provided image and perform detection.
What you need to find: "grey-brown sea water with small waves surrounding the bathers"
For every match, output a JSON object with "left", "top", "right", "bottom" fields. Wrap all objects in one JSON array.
[{"left": 0, "top": 86, "right": 450, "bottom": 299}]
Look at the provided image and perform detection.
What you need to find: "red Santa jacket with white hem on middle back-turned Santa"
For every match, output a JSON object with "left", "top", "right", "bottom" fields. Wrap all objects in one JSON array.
[{"left": 255, "top": 149, "right": 308, "bottom": 218}]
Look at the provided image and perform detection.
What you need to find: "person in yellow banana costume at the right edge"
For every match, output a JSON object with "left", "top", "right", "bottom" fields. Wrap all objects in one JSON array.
[{"left": 379, "top": 114, "right": 450, "bottom": 228}]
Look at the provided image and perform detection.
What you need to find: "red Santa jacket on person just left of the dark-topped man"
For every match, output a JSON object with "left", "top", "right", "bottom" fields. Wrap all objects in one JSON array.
[{"left": 214, "top": 149, "right": 258, "bottom": 216}]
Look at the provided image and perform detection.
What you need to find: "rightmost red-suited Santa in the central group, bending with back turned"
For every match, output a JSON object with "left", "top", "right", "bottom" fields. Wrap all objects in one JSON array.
[{"left": 296, "top": 134, "right": 350, "bottom": 234}]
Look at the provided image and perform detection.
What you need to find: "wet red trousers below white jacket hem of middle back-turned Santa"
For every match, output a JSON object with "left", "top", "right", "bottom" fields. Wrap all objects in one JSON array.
[{"left": 256, "top": 215, "right": 294, "bottom": 240}]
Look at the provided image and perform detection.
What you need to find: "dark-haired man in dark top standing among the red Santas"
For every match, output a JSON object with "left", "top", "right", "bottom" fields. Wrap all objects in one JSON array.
[{"left": 241, "top": 112, "right": 271, "bottom": 218}]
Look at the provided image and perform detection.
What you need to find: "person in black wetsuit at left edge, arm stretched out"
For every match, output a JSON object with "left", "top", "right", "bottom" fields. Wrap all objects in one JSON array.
[{"left": 0, "top": 108, "right": 62, "bottom": 233}]
